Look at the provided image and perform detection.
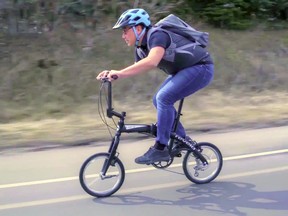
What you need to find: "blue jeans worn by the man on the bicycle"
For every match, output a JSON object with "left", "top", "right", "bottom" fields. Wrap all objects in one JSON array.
[{"left": 153, "top": 64, "right": 214, "bottom": 145}]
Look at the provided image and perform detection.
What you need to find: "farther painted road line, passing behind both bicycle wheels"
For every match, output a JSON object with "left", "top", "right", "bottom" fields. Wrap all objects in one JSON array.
[{"left": 0, "top": 149, "right": 288, "bottom": 189}]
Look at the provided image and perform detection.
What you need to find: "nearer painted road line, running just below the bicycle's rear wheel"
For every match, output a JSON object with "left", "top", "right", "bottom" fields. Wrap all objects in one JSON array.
[{"left": 0, "top": 166, "right": 288, "bottom": 210}]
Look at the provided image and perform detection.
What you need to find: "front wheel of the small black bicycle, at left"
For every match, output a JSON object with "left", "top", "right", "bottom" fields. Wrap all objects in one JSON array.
[{"left": 79, "top": 153, "right": 125, "bottom": 197}]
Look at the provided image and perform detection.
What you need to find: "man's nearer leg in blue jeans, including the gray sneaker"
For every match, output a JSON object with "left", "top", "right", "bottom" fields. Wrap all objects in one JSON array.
[{"left": 135, "top": 65, "right": 214, "bottom": 164}]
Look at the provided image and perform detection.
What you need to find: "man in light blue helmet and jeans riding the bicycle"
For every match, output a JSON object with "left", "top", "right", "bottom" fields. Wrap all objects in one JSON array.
[{"left": 97, "top": 8, "right": 214, "bottom": 164}]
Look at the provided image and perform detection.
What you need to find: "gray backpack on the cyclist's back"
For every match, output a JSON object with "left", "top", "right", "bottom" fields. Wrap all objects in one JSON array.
[{"left": 154, "top": 14, "right": 209, "bottom": 48}]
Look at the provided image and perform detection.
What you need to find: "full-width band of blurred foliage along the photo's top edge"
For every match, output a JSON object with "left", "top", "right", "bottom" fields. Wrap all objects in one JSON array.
[{"left": 0, "top": 0, "right": 288, "bottom": 33}]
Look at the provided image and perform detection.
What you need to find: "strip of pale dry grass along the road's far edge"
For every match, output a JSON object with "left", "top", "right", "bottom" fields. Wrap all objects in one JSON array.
[{"left": 0, "top": 88, "right": 288, "bottom": 147}]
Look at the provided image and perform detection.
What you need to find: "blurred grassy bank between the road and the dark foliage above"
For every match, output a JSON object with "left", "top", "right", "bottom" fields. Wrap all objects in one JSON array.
[{"left": 0, "top": 27, "right": 288, "bottom": 146}]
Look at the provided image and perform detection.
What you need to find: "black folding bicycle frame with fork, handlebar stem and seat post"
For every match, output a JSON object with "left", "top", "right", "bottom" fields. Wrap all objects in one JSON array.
[{"left": 102, "top": 80, "right": 208, "bottom": 175}]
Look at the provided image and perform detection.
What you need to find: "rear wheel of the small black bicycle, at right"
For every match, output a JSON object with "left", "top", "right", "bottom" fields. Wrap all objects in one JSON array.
[{"left": 183, "top": 142, "right": 223, "bottom": 184}]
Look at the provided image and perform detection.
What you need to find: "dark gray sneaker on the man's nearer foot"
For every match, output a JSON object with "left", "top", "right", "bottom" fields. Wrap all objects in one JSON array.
[{"left": 135, "top": 146, "right": 171, "bottom": 164}]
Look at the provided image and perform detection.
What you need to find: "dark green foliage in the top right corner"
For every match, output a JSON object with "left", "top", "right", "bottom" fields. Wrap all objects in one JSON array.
[{"left": 179, "top": 0, "right": 288, "bottom": 30}]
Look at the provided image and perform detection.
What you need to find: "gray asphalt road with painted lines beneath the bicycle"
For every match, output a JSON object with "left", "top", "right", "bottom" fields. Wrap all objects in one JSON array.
[{"left": 0, "top": 127, "right": 288, "bottom": 216}]
